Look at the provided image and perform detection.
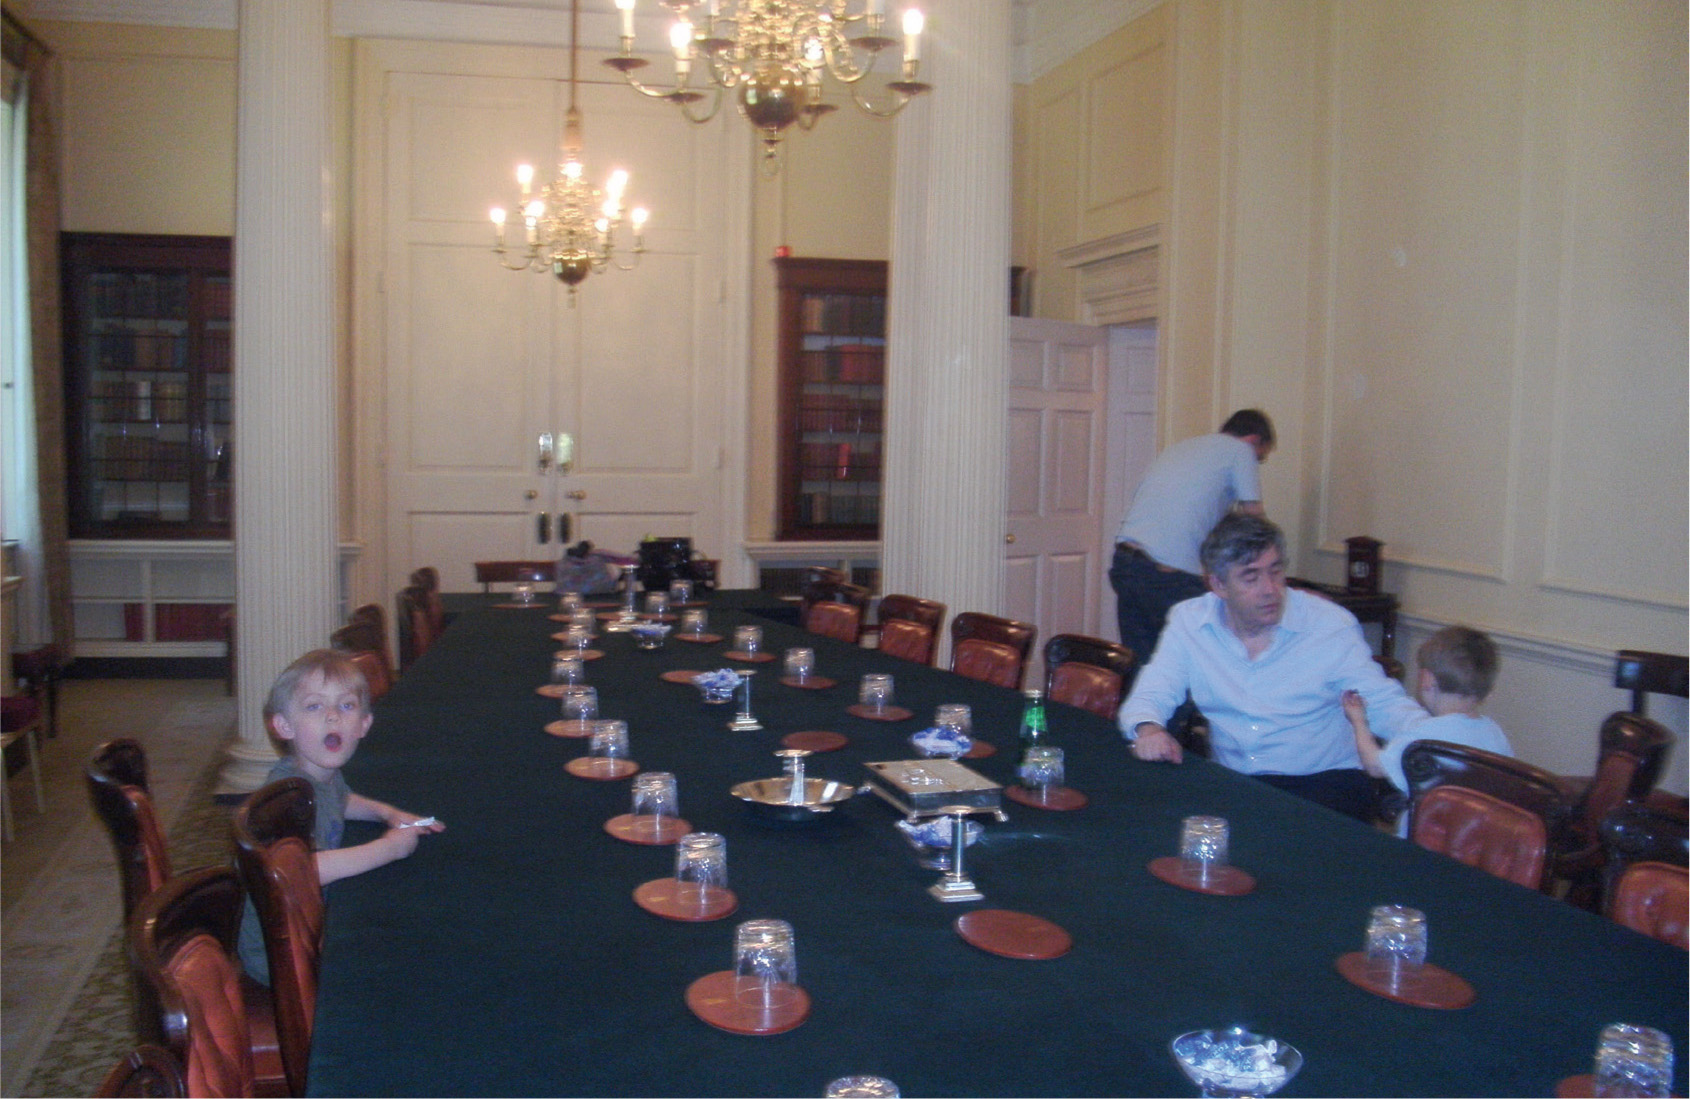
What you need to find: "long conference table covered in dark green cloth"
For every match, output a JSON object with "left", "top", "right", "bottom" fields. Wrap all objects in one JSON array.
[{"left": 311, "top": 592, "right": 1690, "bottom": 1096}]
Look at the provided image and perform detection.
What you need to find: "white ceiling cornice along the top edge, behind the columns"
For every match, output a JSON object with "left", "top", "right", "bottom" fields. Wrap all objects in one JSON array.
[{"left": 20, "top": 0, "right": 1163, "bottom": 83}]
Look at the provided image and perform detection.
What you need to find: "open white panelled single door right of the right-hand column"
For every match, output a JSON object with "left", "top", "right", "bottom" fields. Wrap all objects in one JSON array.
[{"left": 1004, "top": 318, "right": 1109, "bottom": 686}]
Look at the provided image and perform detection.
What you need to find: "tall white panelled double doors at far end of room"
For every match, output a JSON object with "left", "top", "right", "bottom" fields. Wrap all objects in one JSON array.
[{"left": 358, "top": 42, "right": 744, "bottom": 590}]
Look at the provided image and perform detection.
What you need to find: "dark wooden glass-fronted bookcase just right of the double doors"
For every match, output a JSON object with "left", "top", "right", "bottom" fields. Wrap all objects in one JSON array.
[{"left": 774, "top": 257, "right": 886, "bottom": 541}]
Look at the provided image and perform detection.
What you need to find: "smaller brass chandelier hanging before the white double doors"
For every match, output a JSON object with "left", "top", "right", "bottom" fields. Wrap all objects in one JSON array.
[{"left": 492, "top": 0, "right": 649, "bottom": 297}]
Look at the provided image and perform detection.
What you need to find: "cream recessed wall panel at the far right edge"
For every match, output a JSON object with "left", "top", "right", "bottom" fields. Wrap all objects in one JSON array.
[{"left": 1543, "top": 3, "right": 1690, "bottom": 607}]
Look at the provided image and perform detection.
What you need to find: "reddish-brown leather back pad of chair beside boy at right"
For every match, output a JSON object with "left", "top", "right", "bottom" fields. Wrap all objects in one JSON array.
[{"left": 1409, "top": 786, "right": 1548, "bottom": 889}]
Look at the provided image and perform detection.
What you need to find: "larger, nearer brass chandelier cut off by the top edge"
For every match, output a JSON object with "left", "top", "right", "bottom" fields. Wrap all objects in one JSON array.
[{"left": 605, "top": 0, "right": 931, "bottom": 174}]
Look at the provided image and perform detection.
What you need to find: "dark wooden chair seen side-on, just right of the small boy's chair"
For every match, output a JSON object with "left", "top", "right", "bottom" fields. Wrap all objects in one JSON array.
[{"left": 1555, "top": 710, "right": 1673, "bottom": 911}]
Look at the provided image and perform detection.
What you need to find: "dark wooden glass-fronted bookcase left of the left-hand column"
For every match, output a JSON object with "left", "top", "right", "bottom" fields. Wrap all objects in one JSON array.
[{"left": 61, "top": 233, "right": 233, "bottom": 538}]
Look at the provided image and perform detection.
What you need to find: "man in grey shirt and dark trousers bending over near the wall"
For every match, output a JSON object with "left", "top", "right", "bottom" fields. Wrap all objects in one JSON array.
[{"left": 1109, "top": 409, "right": 1274, "bottom": 668}]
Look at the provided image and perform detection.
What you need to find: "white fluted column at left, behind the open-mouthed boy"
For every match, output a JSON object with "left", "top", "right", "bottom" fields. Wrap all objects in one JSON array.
[{"left": 218, "top": 0, "right": 338, "bottom": 793}]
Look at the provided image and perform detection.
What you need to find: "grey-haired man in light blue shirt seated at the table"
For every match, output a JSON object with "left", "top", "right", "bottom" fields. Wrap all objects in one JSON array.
[{"left": 1120, "top": 514, "right": 1426, "bottom": 820}]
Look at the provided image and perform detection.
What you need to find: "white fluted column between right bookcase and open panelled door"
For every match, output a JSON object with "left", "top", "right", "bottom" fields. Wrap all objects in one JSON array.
[{"left": 880, "top": 0, "right": 1012, "bottom": 651}]
